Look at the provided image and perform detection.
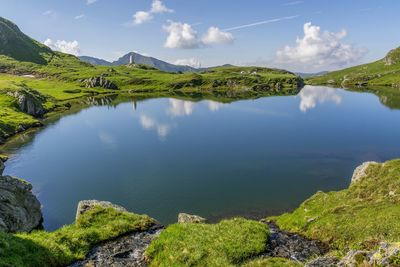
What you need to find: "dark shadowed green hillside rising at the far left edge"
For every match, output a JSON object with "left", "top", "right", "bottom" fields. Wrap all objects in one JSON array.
[{"left": 0, "top": 17, "right": 53, "bottom": 64}]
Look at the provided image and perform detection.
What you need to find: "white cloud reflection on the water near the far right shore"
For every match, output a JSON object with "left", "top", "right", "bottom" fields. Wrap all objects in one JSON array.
[{"left": 298, "top": 86, "right": 342, "bottom": 112}]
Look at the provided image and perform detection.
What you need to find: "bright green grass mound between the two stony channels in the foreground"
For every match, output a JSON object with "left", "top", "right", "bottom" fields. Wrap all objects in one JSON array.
[{"left": 146, "top": 218, "right": 269, "bottom": 266}]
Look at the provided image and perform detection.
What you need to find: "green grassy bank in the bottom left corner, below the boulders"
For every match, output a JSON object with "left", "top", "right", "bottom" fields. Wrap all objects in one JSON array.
[{"left": 0, "top": 207, "right": 154, "bottom": 267}]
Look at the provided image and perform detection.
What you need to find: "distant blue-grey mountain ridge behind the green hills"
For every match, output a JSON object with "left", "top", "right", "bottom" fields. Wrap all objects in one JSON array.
[{"left": 79, "top": 52, "right": 199, "bottom": 72}]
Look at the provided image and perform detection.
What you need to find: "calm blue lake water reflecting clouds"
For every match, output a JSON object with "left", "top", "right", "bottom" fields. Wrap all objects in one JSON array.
[{"left": 5, "top": 86, "right": 400, "bottom": 229}]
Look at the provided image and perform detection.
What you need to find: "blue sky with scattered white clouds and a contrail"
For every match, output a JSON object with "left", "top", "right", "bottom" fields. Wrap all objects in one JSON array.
[{"left": 0, "top": 0, "right": 400, "bottom": 72}]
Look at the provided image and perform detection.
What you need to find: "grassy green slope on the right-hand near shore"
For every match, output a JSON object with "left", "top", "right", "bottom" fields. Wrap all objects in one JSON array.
[{"left": 270, "top": 160, "right": 400, "bottom": 252}]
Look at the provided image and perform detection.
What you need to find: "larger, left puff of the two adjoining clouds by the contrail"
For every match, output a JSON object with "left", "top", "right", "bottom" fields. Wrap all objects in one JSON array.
[{"left": 163, "top": 21, "right": 201, "bottom": 49}]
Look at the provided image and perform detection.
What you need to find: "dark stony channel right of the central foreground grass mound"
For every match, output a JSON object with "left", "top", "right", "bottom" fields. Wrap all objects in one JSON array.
[{"left": 264, "top": 222, "right": 328, "bottom": 262}]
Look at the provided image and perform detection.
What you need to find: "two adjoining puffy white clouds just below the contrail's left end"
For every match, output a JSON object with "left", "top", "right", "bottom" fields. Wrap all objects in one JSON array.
[{"left": 163, "top": 21, "right": 234, "bottom": 49}]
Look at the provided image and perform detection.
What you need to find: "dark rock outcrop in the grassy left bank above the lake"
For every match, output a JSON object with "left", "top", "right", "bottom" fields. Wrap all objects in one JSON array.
[{"left": 7, "top": 89, "right": 46, "bottom": 117}]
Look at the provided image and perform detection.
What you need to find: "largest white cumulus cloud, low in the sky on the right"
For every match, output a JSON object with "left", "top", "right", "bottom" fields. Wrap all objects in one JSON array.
[{"left": 277, "top": 22, "right": 366, "bottom": 68}]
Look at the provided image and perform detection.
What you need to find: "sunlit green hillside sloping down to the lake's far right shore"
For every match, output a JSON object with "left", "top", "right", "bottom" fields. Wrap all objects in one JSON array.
[{"left": 307, "top": 47, "right": 400, "bottom": 88}]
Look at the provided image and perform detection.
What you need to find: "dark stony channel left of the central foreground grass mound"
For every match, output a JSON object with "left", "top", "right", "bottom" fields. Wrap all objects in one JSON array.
[{"left": 70, "top": 225, "right": 163, "bottom": 267}]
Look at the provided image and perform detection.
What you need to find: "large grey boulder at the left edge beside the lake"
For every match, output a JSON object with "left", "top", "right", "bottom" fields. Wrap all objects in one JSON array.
[{"left": 0, "top": 176, "right": 42, "bottom": 232}]
